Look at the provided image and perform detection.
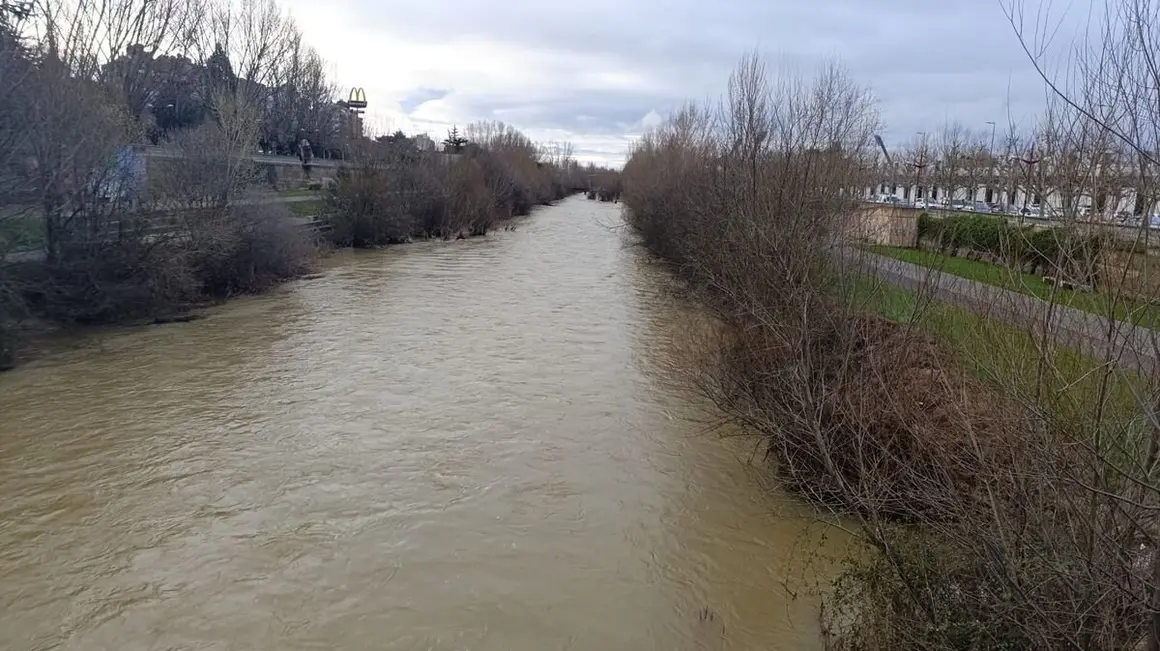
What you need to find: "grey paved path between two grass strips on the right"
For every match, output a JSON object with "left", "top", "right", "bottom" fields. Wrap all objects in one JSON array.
[{"left": 844, "top": 249, "right": 1160, "bottom": 375}]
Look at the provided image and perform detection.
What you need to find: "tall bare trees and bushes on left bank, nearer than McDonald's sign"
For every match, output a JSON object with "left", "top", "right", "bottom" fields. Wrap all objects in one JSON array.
[{"left": 0, "top": 0, "right": 327, "bottom": 366}]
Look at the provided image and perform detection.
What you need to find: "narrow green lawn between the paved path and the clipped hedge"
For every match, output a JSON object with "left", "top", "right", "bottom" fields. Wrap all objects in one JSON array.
[{"left": 869, "top": 246, "right": 1160, "bottom": 328}]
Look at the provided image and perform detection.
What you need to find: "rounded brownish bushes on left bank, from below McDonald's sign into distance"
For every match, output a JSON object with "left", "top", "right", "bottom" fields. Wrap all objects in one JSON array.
[{"left": 324, "top": 122, "right": 586, "bottom": 247}]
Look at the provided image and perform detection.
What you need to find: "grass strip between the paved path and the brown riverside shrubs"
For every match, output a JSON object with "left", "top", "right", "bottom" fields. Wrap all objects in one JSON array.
[{"left": 848, "top": 276, "right": 1151, "bottom": 427}]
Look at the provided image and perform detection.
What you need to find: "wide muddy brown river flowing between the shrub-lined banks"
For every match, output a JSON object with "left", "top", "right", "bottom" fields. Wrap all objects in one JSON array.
[{"left": 0, "top": 197, "right": 841, "bottom": 651}]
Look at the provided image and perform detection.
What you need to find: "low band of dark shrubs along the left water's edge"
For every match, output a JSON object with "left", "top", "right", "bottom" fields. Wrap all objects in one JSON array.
[{"left": 0, "top": 123, "right": 598, "bottom": 370}]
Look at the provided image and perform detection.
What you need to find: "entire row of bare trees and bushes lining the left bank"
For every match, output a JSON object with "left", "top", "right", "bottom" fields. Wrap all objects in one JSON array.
[{"left": 0, "top": 0, "right": 585, "bottom": 368}]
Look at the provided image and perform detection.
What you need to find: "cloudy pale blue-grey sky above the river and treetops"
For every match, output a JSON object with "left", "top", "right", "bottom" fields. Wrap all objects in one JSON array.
[{"left": 283, "top": 0, "right": 1076, "bottom": 165}]
